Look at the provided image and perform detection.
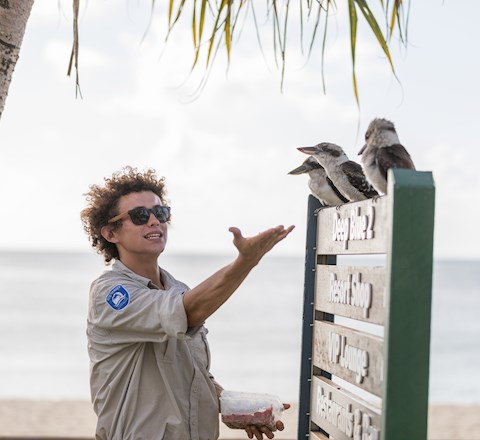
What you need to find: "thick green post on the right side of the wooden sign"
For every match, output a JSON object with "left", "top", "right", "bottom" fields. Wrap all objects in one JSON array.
[{"left": 381, "top": 169, "right": 435, "bottom": 440}]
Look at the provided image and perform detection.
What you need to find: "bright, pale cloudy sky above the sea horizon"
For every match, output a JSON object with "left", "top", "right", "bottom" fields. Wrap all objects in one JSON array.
[{"left": 0, "top": 0, "right": 480, "bottom": 259}]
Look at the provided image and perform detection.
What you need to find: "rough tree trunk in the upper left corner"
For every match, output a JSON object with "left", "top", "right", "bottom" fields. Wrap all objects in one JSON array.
[{"left": 0, "top": 0, "right": 34, "bottom": 118}]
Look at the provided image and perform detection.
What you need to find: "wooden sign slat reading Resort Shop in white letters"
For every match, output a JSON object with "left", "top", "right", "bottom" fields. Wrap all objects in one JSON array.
[{"left": 315, "top": 265, "right": 386, "bottom": 324}]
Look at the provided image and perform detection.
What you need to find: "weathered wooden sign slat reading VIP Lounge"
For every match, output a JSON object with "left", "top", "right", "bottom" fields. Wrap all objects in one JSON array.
[{"left": 313, "top": 321, "right": 383, "bottom": 396}]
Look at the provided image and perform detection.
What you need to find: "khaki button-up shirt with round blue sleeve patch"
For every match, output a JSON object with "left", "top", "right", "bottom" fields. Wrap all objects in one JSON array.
[{"left": 87, "top": 261, "right": 219, "bottom": 440}]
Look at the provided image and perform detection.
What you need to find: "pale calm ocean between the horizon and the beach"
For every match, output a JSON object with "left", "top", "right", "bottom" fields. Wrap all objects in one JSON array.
[{"left": 0, "top": 252, "right": 480, "bottom": 404}]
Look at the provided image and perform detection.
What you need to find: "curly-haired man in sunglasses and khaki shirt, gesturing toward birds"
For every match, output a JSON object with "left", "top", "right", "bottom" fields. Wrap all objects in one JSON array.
[{"left": 81, "top": 167, "right": 293, "bottom": 440}]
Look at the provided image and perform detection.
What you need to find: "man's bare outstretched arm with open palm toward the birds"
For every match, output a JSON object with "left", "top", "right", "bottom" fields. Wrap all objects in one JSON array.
[{"left": 183, "top": 226, "right": 294, "bottom": 327}]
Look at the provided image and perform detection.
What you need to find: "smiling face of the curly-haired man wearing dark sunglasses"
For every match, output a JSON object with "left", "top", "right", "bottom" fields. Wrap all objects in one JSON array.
[{"left": 108, "top": 191, "right": 167, "bottom": 260}]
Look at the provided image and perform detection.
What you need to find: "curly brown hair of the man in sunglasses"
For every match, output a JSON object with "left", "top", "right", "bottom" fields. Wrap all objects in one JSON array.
[{"left": 80, "top": 166, "right": 167, "bottom": 264}]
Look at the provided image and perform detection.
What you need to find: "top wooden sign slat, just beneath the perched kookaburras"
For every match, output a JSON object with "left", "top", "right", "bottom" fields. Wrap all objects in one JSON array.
[{"left": 317, "top": 196, "right": 387, "bottom": 255}]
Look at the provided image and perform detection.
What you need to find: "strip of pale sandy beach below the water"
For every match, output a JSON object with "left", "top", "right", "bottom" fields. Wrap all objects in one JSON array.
[{"left": 0, "top": 400, "right": 480, "bottom": 440}]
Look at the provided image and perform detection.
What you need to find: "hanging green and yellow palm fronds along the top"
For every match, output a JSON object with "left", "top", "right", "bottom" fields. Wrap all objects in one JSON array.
[{"left": 69, "top": 0, "right": 409, "bottom": 104}]
